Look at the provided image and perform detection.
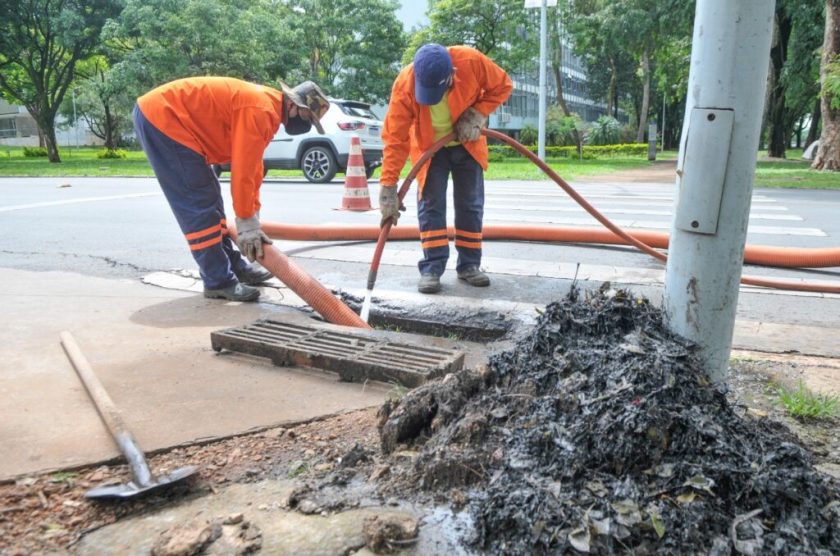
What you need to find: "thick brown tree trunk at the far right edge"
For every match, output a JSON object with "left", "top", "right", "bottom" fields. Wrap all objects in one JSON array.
[{"left": 811, "top": 0, "right": 840, "bottom": 171}]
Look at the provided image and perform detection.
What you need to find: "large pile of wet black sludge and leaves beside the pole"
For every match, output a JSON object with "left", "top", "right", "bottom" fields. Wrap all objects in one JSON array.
[{"left": 380, "top": 287, "right": 840, "bottom": 555}]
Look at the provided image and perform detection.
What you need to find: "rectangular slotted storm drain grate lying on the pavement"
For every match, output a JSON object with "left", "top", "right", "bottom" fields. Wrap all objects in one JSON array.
[{"left": 210, "top": 320, "right": 464, "bottom": 387}]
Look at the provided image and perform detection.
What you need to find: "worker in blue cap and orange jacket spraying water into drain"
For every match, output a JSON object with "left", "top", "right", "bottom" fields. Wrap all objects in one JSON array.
[{"left": 379, "top": 44, "right": 513, "bottom": 293}]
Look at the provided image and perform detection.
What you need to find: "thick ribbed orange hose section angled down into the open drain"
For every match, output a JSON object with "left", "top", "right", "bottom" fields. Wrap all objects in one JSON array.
[{"left": 228, "top": 223, "right": 370, "bottom": 328}]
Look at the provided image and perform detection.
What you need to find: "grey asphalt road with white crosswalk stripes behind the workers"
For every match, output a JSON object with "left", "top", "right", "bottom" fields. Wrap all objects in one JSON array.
[{"left": 0, "top": 178, "right": 840, "bottom": 326}]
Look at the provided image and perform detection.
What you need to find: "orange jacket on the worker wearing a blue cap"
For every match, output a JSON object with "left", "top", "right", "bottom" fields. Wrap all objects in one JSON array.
[{"left": 379, "top": 46, "right": 513, "bottom": 195}]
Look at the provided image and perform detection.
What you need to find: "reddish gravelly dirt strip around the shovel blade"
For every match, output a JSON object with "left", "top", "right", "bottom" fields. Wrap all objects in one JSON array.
[{"left": 0, "top": 410, "right": 378, "bottom": 556}]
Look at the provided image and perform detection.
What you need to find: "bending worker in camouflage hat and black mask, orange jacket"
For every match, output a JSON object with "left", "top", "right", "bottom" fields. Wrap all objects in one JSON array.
[{"left": 134, "top": 77, "right": 329, "bottom": 301}]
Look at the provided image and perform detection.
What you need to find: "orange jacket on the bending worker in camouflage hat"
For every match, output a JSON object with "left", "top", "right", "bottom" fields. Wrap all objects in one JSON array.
[{"left": 137, "top": 77, "right": 283, "bottom": 218}]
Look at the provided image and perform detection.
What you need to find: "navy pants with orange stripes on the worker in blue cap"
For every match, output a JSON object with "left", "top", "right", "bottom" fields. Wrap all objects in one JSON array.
[{"left": 417, "top": 145, "right": 484, "bottom": 276}]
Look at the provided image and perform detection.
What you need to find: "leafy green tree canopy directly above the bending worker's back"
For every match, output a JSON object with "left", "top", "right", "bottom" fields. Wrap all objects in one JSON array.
[{"left": 104, "top": 0, "right": 304, "bottom": 94}]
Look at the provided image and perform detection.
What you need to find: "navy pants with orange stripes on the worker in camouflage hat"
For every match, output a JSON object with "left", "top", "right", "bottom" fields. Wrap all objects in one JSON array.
[{"left": 134, "top": 106, "right": 248, "bottom": 290}]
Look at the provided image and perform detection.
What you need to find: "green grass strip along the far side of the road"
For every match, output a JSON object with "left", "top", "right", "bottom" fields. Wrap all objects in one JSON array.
[{"left": 0, "top": 146, "right": 840, "bottom": 189}]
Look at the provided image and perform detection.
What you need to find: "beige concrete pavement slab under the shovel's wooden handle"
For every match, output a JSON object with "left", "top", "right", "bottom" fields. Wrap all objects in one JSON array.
[{"left": 0, "top": 269, "right": 389, "bottom": 480}]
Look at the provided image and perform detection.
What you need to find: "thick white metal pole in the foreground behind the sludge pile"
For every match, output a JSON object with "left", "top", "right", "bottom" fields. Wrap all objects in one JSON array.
[{"left": 664, "top": 0, "right": 775, "bottom": 382}]
